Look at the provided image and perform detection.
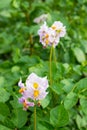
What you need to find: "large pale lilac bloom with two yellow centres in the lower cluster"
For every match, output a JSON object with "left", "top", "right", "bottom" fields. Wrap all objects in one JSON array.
[{"left": 24, "top": 73, "right": 48, "bottom": 100}]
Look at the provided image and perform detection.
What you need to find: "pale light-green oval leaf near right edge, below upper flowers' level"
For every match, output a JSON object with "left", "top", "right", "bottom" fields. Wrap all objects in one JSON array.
[{"left": 73, "top": 47, "right": 86, "bottom": 63}]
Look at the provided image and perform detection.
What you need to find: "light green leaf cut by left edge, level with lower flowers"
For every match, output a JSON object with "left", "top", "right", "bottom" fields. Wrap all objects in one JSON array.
[{"left": 0, "top": 88, "right": 10, "bottom": 102}]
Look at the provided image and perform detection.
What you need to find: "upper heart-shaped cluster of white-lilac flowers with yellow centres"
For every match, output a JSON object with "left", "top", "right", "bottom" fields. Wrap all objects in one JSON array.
[{"left": 38, "top": 21, "right": 66, "bottom": 47}]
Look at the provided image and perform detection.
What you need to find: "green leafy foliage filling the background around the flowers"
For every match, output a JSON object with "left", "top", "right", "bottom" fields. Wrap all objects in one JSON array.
[{"left": 0, "top": 0, "right": 87, "bottom": 130}]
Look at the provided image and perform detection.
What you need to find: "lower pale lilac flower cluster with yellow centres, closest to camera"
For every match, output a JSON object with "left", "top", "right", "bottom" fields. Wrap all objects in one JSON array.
[{"left": 18, "top": 73, "right": 48, "bottom": 110}]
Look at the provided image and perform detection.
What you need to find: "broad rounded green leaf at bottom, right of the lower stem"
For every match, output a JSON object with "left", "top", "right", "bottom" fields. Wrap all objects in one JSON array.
[{"left": 50, "top": 105, "right": 69, "bottom": 127}]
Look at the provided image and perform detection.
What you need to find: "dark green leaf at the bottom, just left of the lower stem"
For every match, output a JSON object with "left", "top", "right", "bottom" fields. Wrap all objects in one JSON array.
[{"left": 12, "top": 108, "right": 28, "bottom": 128}]
